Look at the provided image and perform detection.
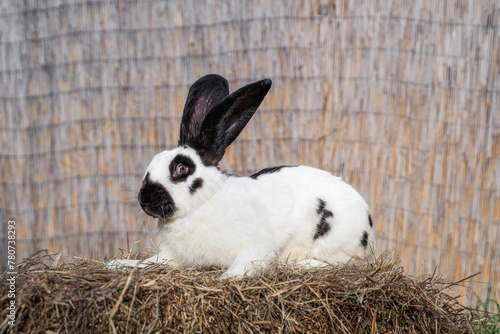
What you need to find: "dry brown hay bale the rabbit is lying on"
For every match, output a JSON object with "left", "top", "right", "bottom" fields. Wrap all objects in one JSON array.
[{"left": 0, "top": 252, "right": 477, "bottom": 333}]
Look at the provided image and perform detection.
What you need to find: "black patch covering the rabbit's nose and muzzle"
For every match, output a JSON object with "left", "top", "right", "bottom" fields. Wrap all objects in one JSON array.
[{"left": 138, "top": 173, "right": 177, "bottom": 218}]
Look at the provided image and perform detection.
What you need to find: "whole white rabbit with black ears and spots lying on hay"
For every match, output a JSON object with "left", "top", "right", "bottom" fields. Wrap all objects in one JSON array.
[{"left": 108, "top": 74, "right": 375, "bottom": 279}]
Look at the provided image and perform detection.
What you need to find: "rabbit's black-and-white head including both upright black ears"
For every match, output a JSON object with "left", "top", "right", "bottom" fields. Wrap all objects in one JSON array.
[{"left": 138, "top": 74, "right": 271, "bottom": 219}]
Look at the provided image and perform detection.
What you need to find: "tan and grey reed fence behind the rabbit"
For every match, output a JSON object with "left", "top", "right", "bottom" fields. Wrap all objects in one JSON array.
[{"left": 0, "top": 0, "right": 500, "bottom": 308}]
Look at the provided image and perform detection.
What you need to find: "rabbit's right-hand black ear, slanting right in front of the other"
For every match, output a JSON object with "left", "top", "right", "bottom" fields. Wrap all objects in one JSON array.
[{"left": 193, "top": 79, "right": 272, "bottom": 165}]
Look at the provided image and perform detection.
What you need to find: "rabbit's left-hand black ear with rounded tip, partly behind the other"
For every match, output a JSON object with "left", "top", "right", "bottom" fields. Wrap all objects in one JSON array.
[{"left": 179, "top": 74, "right": 229, "bottom": 146}]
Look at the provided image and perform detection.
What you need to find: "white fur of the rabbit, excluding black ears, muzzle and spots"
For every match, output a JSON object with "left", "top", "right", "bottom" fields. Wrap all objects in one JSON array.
[{"left": 108, "top": 147, "right": 375, "bottom": 278}]
